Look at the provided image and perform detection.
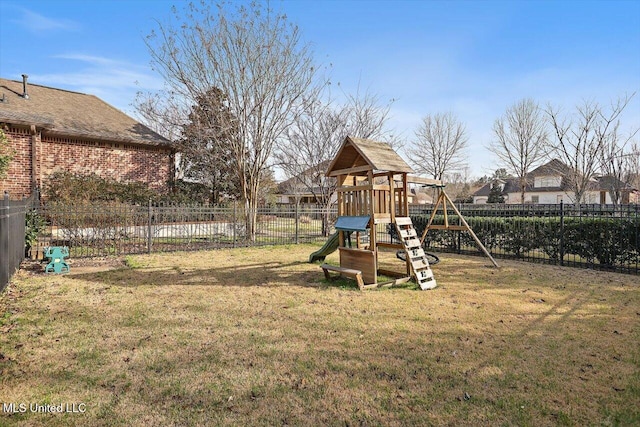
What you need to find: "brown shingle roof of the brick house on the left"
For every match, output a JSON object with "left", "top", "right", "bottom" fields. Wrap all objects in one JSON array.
[{"left": 0, "top": 78, "right": 171, "bottom": 146}]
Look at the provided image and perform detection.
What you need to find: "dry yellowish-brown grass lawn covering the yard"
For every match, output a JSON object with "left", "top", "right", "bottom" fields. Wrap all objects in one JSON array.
[{"left": 0, "top": 245, "right": 640, "bottom": 426}]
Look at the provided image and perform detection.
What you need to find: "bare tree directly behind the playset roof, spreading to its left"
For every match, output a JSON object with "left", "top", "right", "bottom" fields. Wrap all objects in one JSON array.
[{"left": 275, "top": 91, "right": 393, "bottom": 235}]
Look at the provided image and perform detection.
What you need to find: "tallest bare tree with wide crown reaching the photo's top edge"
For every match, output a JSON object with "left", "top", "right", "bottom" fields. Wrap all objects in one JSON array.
[{"left": 147, "top": 1, "right": 317, "bottom": 240}]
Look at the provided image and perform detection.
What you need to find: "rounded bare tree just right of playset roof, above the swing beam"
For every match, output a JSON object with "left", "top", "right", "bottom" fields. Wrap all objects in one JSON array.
[{"left": 408, "top": 113, "right": 468, "bottom": 180}]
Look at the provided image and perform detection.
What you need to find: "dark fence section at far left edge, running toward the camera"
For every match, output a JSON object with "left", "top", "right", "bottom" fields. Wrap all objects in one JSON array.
[{"left": 0, "top": 193, "right": 35, "bottom": 292}]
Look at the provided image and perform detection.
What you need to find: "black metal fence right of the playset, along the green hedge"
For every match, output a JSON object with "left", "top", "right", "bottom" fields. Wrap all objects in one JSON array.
[{"left": 411, "top": 203, "right": 640, "bottom": 274}]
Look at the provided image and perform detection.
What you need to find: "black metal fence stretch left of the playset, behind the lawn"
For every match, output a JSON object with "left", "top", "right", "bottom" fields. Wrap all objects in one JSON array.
[{"left": 41, "top": 202, "right": 335, "bottom": 258}]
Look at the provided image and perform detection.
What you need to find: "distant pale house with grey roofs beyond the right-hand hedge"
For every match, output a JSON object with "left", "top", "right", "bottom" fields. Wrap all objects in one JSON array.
[{"left": 473, "top": 159, "right": 637, "bottom": 204}]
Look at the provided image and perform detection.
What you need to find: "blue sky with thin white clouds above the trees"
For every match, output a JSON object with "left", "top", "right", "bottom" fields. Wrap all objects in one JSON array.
[{"left": 0, "top": 0, "right": 640, "bottom": 176}]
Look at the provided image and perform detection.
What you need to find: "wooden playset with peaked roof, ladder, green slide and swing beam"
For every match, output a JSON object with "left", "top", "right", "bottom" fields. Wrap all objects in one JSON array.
[{"left": 321, "top": 136, "right": 497, "bottom": 289}]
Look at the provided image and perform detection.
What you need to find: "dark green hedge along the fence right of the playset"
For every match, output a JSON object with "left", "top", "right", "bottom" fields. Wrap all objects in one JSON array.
[{"left": 412, "top": 215, "right": 640, "bottom": 267}]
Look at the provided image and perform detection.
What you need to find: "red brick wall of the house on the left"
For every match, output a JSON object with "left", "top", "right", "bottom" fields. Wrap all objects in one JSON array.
[{"left": 0, "top": 128, "right": 173, "bottom": 199}]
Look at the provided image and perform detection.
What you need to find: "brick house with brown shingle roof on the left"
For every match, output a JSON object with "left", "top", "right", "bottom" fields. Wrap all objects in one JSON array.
[{"left": 0, "top": 75, "right": 174, "bottom": 198}]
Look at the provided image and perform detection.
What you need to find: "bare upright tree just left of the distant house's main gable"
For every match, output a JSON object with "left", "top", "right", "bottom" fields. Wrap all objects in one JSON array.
[{"left": 488, "top": 99, "right": 547, "bottom": 204}]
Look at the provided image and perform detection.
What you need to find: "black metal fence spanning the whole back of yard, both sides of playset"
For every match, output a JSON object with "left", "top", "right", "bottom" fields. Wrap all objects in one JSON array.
[{"left": 28, "top": 203, "right": 640, "bottom": 274}]
